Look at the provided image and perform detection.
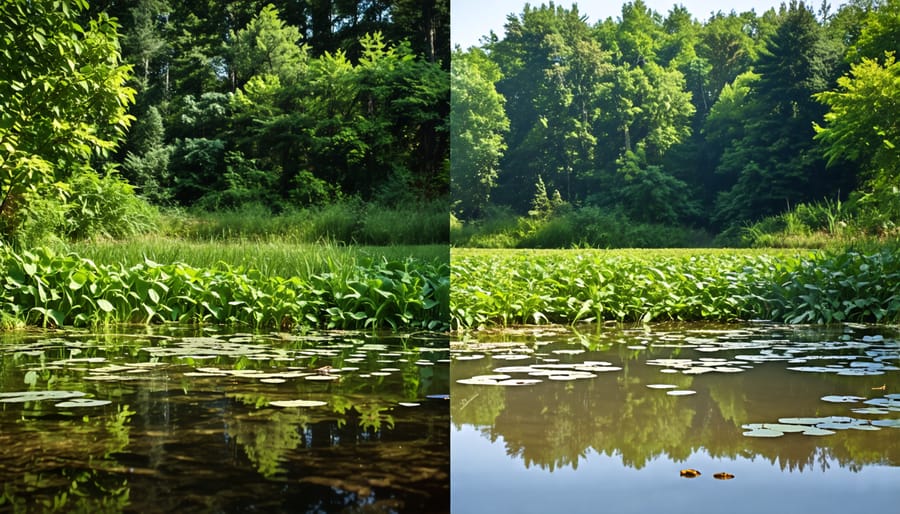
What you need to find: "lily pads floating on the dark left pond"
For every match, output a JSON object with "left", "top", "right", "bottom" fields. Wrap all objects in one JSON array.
[{"left": 0, "top": 332, "right": 449, "bottom": 418}]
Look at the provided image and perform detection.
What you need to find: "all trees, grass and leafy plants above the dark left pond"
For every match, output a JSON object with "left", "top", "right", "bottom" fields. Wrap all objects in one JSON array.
[{"left": 0, "top": 0, "right": 450, "bottom": 330}]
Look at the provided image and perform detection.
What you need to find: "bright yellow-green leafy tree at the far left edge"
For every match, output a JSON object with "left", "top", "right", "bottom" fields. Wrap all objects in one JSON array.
[{"left": 0, "top": 0, "right": 134, "bottom": 237}]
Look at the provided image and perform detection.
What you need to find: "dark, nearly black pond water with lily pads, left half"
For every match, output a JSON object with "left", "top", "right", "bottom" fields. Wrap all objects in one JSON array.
[{"left": 0, "top": 327, "right": 450, "bottom": 513}]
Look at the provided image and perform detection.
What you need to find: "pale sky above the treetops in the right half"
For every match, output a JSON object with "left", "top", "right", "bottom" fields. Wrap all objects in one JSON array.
[{"left": 450, "top": 0, "right": 804, "bottom": 49}]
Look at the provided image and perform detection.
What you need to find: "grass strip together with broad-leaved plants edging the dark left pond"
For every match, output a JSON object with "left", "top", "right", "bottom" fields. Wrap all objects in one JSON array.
[{"left": 0, "top": 245, "right": 450, "bottom": 330}]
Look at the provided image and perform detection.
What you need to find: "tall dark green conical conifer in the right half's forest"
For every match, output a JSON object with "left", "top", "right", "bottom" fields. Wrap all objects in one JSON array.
[{"left": 715, "top": 3, "right": 847, "bottom": 226}]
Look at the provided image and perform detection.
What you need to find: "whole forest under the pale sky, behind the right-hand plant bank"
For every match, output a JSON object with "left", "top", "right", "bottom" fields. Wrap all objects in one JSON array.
[{"left": 451, "top": 0, "right": 900, "bottom": 248}]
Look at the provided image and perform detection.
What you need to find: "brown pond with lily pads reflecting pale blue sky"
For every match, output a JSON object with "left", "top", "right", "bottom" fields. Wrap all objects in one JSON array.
[{"left": 450, "top": 323, "right": 900, "bottom": 514}]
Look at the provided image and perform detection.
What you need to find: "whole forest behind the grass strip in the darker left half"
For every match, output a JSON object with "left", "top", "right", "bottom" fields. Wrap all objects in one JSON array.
[{"left": 0, "top": 0, "right": 450, "bottom": 247}]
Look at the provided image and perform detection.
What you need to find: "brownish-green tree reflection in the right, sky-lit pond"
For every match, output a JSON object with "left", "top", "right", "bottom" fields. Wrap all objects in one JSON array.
[{"left": 451, "top": 326, "right": 900, "bottom": 471}]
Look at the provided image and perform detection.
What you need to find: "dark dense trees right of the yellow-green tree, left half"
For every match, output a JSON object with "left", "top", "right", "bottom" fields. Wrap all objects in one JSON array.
[{"left": 112, "top": 0, "right": 449, "bottom": 208}]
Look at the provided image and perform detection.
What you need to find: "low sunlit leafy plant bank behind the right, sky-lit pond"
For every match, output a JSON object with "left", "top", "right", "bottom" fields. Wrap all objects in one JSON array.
[{"left": 450, "top": 249, "right": 900, "bottom": 329}]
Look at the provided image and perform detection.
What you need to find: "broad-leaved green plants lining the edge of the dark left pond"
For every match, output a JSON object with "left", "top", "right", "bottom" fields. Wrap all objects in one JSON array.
[{"left": 0, "top": 248, "right": 450, "bottom": 330}]
